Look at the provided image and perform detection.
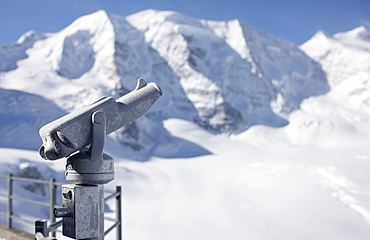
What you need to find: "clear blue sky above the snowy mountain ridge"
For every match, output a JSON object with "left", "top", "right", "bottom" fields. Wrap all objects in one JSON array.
[{"left": 0, "top": 0, "right": 370, "bottom": 46}]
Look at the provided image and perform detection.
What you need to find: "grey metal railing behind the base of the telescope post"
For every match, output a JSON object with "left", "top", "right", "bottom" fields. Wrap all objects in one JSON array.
[{"left": 0, "top": 174, "right": 122, "bottom": 240}]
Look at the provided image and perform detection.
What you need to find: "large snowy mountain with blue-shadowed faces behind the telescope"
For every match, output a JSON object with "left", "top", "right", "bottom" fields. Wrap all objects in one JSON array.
[{"left": 0, "top": 10, "right": 329, "bottom": 156}]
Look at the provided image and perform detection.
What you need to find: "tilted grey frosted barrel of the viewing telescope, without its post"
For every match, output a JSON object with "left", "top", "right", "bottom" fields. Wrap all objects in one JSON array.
[{"left": 39, "top": 79, "right": 163, "bottom": 160}]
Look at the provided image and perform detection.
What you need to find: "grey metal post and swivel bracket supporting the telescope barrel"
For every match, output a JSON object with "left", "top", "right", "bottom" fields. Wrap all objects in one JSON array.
[{"left": 54, "top": 112, "right": 114, "bottom": 240}]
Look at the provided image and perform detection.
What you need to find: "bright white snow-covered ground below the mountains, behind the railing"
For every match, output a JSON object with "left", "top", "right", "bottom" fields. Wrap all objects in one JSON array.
[{"left": 0, "top": 102, "right": 370, "bottom": 240}]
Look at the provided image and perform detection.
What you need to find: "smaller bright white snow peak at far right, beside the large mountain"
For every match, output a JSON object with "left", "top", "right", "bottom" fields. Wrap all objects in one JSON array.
[{"left": 301, "top": 27, "right": 370, "bottom": 113}]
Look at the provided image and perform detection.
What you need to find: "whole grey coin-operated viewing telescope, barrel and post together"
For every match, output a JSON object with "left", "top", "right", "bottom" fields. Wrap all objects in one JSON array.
[{"left": 40, "top": 79, "right": 163, "bottom": 240}]
